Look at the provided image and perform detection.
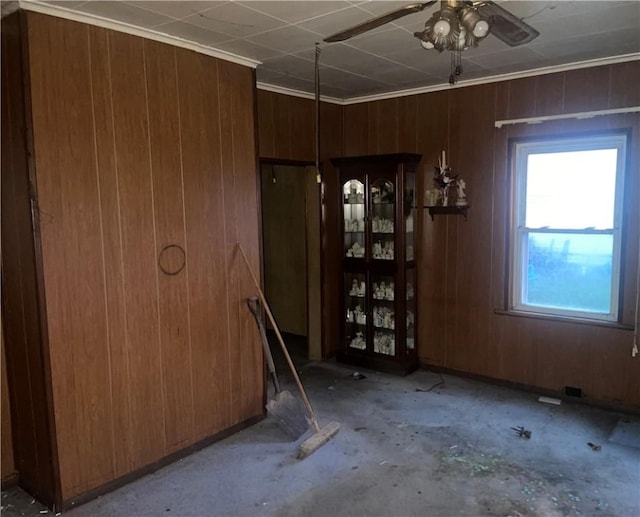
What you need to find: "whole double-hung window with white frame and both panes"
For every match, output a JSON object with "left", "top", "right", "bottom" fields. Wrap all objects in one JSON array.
[{"left": 511, "top": 133, "right": 627, "bottom": 321}]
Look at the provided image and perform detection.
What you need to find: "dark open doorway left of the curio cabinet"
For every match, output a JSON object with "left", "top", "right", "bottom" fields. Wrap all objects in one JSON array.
[{"left": 260, "top": 160, "right": 322, "bottom": 360}]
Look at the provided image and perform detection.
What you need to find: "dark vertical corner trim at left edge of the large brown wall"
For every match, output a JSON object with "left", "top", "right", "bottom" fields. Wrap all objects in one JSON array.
[{"left": 20, "top": 11, "right": 62, "bottom": 508}]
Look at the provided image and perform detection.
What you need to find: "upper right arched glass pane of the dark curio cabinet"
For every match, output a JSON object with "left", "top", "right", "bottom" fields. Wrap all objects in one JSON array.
[{"left": 371, "top": 180, "right": 396, "bottom": 260}]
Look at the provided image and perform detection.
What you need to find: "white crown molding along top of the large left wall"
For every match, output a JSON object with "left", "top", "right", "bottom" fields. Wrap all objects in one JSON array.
[{"left": 16, "top": 0, "right": 262, "bottom": 68}]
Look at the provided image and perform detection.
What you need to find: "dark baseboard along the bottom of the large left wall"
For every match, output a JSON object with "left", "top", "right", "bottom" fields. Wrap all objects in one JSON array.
[{"left": 57, "top": 414, "right": 266, "bottom": 511}]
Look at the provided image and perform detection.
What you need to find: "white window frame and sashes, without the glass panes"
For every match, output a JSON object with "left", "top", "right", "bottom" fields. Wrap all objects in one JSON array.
[{"left": 507, "top": 130, "right": 631, "bottom": 323}]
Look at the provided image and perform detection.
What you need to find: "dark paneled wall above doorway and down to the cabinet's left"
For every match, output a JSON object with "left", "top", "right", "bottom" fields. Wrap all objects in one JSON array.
[{"left": 258, "top": 90, "right": 343, "bottom": 357}]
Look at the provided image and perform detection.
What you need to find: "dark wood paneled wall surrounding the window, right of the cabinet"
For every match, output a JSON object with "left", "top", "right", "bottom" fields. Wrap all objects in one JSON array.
[{"left": 344, "top": 61, "right": 640, "bottom": 407}]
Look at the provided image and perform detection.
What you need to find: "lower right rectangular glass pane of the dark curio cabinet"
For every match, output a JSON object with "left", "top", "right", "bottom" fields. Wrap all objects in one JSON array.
[{"left": 371, "top": 275, "right": 396, "bottom": 355}]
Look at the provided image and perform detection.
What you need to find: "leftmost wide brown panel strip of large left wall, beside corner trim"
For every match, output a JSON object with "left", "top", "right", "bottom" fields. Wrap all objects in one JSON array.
[{"left": 29, "top": 13, "right": 112, "bottom": 496}]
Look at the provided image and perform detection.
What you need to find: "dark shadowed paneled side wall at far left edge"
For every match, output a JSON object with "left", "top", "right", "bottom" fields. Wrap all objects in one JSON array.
[{"left": 2, "top": 13, "right": 56, "bottom": 504}]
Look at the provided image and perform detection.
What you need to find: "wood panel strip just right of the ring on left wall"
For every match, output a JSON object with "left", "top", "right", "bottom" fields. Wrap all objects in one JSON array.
[{"left": 176, "top": 50, "right": 232, "bottom": 438}]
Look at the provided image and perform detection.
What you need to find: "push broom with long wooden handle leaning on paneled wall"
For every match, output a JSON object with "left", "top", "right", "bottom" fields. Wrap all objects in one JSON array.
[{"left": 237, "top": 243, "right": 340, "bottom": 459}]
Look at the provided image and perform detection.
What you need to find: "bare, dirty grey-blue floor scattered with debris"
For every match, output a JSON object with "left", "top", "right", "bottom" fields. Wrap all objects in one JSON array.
[{"left": 2, "top": 362, "right": 640, "bottom": 517}]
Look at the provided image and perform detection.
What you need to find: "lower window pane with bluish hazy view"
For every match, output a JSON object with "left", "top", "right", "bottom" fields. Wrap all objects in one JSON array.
[{"left": 522, "top": 232, "right": 613, "bottom": 314}]
